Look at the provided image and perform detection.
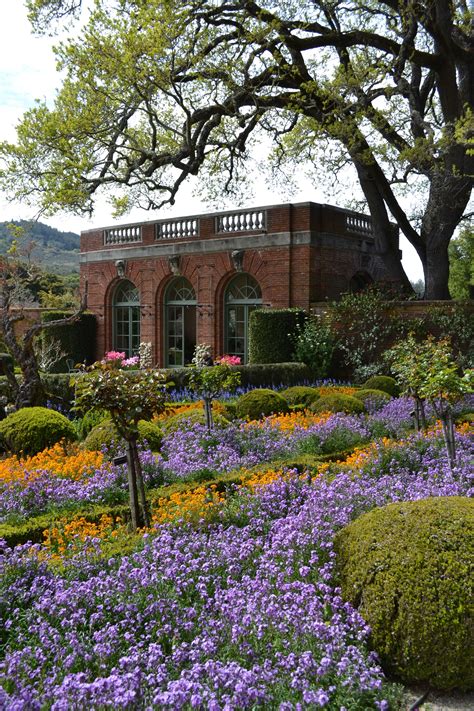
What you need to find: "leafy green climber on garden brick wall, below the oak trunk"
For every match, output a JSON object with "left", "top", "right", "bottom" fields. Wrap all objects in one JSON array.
[{"left": 328, "top": 289, "right": 400, "bottom": 382}]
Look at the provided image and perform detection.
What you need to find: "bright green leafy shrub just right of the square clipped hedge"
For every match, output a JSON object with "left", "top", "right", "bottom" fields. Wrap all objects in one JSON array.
[{"left": 294, "top": 317, "right": 335, "bottom": 378}]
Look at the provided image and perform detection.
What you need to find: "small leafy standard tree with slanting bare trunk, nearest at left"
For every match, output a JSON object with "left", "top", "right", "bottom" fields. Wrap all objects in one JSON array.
[{"left": 75, "top": 351, "right": 166, "bottom": 529}]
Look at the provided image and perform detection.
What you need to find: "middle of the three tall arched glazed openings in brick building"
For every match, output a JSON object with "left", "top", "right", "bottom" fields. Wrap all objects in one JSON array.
[{"left": 165, "top": 277, "right": 196, "bottom": 368}]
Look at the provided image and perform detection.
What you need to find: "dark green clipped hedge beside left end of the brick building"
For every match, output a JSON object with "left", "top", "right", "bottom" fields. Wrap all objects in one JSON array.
[{"left": 40, "top": 311, "right": 97, "bottom": 373}]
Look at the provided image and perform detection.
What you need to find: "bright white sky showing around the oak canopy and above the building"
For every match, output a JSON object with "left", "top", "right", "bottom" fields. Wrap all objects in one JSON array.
[{"left": 0, "top": 0, "right": 422, "bottom": 281}]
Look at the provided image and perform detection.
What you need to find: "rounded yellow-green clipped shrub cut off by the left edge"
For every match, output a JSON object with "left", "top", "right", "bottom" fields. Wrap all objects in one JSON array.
[{"left": 0, "top": 407, "right": 76, "bottom": 455}]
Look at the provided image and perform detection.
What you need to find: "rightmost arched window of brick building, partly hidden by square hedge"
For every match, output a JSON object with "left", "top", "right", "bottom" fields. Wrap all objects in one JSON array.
[{"left": 224, "top": 274, "right": 262, "bottom": 363}]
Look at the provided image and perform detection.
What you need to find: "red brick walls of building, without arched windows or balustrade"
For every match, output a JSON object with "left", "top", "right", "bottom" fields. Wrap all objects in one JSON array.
[{"left": 81, "top": 203, "right": 400, "bottom": 365}]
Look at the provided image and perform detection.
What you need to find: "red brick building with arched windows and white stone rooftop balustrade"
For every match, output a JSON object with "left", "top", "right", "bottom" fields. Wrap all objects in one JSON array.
[{"left": 80, "top": 202, "right": 400, "bottom": 367}]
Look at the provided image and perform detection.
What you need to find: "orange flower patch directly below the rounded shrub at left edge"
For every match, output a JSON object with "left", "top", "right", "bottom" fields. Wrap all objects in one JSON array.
[{"left": 0, "top": 443, "right": 104, "bottom": 482}]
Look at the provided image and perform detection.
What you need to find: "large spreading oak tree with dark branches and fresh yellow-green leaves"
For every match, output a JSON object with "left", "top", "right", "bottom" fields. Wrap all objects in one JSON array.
[{"left": 2, "top": 0, "right": 474, "bottom": 299}]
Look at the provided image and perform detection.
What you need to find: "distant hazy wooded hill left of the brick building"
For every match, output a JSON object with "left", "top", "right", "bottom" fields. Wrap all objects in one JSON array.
[{"left": 0, "top": 220, "right": 80, "bottom": 274}]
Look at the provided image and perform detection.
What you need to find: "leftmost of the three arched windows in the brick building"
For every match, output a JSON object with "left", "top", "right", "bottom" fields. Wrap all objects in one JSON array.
[{"left": 112, "top": 281, "right": 140, "bottom": 358}]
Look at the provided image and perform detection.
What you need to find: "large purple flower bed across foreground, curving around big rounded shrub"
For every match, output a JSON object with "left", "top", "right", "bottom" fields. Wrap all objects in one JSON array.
[{"left": 0, "top": 426, "right": 472, "bottom": 711}]
